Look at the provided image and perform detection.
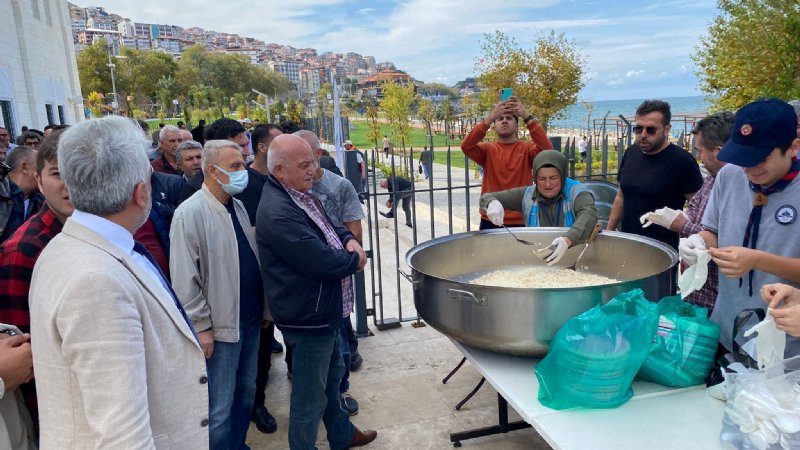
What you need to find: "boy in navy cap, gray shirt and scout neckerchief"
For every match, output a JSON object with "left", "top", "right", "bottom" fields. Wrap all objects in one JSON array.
[{"left": 679, "top": 99, "right": 800, "bottom": 357}]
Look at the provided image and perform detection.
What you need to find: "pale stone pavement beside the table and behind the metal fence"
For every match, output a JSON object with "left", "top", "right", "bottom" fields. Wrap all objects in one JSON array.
[{"left": 247, "top": 156, "right": 550, "bottom": 450}]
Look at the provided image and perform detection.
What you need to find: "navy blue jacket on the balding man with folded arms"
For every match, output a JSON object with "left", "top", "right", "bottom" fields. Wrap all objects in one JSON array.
[{"left": 256, "top": 175, "right": 358, "bottom": 334}]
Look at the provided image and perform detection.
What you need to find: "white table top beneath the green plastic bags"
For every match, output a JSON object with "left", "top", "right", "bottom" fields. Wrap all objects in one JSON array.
[{"left": 451, "top": 339, "right": 725, "bottom": 450}]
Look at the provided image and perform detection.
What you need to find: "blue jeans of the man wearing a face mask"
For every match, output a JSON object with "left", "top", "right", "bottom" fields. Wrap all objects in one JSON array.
[{"left": 206, "top": 319, "right": 261, "bottom": 450}]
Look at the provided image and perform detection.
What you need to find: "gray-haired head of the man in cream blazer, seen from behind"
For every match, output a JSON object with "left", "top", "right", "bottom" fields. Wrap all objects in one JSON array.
[{"left": 58, "top": 116, "right": 151, "bottom": 216}]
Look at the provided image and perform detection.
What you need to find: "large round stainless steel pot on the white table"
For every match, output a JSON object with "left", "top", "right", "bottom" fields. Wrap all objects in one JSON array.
[{"left": 406, "top": 228, "right": 678, "bottom": 356}]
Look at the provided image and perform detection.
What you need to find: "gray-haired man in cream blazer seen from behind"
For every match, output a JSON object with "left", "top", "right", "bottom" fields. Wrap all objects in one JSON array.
[{"left": 30, "top": 116, "right": 208, "bottom": 450}]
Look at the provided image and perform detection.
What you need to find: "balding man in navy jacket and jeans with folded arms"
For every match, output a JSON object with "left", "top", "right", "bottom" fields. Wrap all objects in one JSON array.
[{"left": 256, "top": 135, "right": 377, "bottom": 448}]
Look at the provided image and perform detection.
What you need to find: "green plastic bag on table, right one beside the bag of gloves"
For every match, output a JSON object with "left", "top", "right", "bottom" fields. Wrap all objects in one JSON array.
[{"left": 639, "top": 296, "right": 719, "bottom": 387}]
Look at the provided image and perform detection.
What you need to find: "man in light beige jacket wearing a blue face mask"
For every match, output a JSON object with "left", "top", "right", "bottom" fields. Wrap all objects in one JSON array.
[{"left": 169, "top": 140, "right": 268, "bottom": 449}]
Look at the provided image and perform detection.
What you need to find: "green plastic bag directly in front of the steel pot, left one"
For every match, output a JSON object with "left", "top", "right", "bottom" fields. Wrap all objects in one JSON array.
[{"left": 536, "top": 289, "right": 658, "bottom": 409}]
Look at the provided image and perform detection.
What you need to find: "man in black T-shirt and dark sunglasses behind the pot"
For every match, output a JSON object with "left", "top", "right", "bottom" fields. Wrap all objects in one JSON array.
[{"left": 607, "top": 100, "right": 703, "bottom": 250}]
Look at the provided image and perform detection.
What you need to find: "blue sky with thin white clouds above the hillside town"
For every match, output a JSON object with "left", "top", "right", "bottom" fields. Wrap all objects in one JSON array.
[{"left": 73, "top": 0, "right": 717, "bottom": 101}]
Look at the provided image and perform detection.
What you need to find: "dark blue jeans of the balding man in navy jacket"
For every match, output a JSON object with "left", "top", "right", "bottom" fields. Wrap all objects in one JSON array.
[{"left": 283, "top": 329, "right": 355, "bottom": 450}]
